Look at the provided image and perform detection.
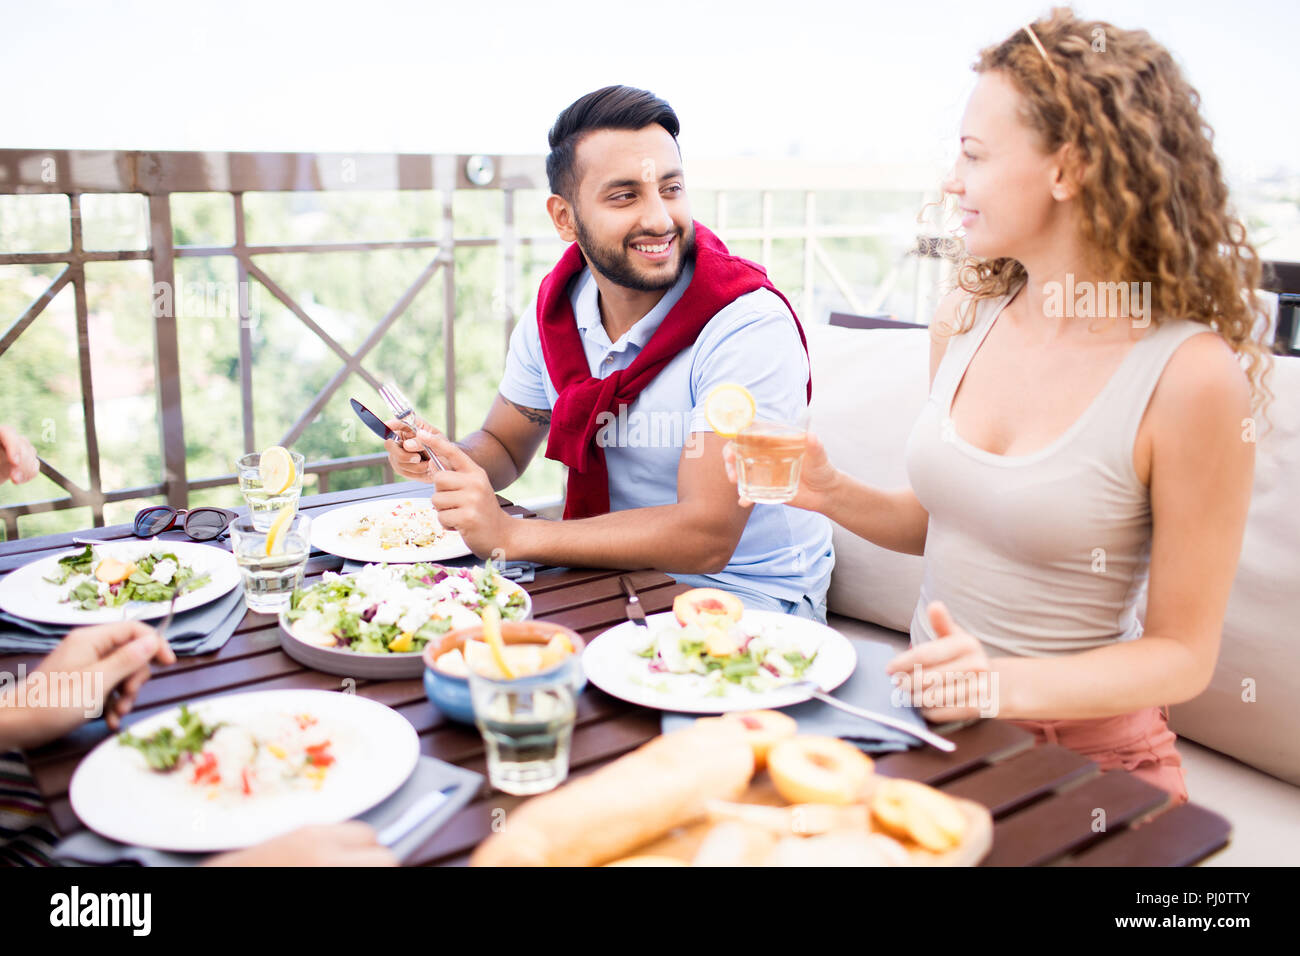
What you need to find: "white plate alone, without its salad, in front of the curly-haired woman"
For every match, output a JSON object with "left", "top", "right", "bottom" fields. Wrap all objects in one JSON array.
[{"left": 582, "top": 610, "right": 858, "bottom": 714}]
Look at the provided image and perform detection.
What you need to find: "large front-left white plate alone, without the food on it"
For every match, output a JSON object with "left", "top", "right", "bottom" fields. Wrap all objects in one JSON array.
[{"left": 68, "top": 691, "right": 420, "bottom": 852}]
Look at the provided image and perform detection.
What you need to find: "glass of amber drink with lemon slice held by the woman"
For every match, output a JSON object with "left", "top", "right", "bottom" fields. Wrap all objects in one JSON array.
[{"left": 705, "top": 384, "right": 807, "bottom": 505}]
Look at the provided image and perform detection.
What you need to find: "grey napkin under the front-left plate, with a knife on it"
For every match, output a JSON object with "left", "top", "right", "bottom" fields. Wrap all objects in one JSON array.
[{"left": 55, "top": 756, "right": 484, "bottom": 866}]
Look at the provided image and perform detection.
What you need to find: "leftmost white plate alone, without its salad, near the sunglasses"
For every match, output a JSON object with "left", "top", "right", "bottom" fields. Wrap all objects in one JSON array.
[{"left": 0, "top": 538, "right": 239, "bottom": 624}]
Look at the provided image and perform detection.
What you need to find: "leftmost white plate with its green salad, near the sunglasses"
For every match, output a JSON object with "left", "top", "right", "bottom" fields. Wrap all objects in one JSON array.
[{"left": 0, "top": 538, "right": 239, "bottom": 626}]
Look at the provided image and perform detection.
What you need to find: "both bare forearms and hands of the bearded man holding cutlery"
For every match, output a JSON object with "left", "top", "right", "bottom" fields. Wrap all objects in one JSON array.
[{"left": 387, "top": 394, "right": 749, "bottom": 574}]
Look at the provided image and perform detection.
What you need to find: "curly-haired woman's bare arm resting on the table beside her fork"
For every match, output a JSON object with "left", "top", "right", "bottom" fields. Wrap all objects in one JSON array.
[{"left": 889, "top": 321, "right": 1255, "bottom": 719}]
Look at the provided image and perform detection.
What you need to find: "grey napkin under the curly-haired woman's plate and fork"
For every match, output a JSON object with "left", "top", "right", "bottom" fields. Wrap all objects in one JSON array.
[{"left": 660, "top": 637, "right": 926, "bottom": 753}]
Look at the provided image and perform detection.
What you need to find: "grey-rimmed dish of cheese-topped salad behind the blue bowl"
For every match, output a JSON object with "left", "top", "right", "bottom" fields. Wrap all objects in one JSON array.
[{"left": 280, "top": 561, "right": 533, "bottom": 680}]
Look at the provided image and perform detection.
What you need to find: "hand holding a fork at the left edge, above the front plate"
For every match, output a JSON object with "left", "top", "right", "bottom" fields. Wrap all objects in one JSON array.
[{"left": 0, "top": 620, "right": 176, "bottom": 750}]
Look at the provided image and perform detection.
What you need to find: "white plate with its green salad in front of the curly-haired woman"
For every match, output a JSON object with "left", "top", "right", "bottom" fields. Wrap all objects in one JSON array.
[{"left": 582, "top": 609, "right": 858, "bottom": 714}]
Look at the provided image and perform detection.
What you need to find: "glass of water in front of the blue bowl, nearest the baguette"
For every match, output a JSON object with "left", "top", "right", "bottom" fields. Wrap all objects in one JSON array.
[{"left": 469, "top": 667, "right": 577, "bottom": 795}]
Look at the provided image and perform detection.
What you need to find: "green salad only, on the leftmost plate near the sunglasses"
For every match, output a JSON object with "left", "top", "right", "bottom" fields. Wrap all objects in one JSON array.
[{"left": 44, "top": 545, "right": 212, "bottom": 611}]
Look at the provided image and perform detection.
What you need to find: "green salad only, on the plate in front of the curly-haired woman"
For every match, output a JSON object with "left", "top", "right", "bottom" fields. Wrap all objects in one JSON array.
[{"left": 632, "top": 620, "right": 819, "bottom": 697}]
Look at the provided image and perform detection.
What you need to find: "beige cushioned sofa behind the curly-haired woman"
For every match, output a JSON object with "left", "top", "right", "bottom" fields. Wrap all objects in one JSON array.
[{"left": 807, "top": 325, "right": 1300, "bottom": 866}]
